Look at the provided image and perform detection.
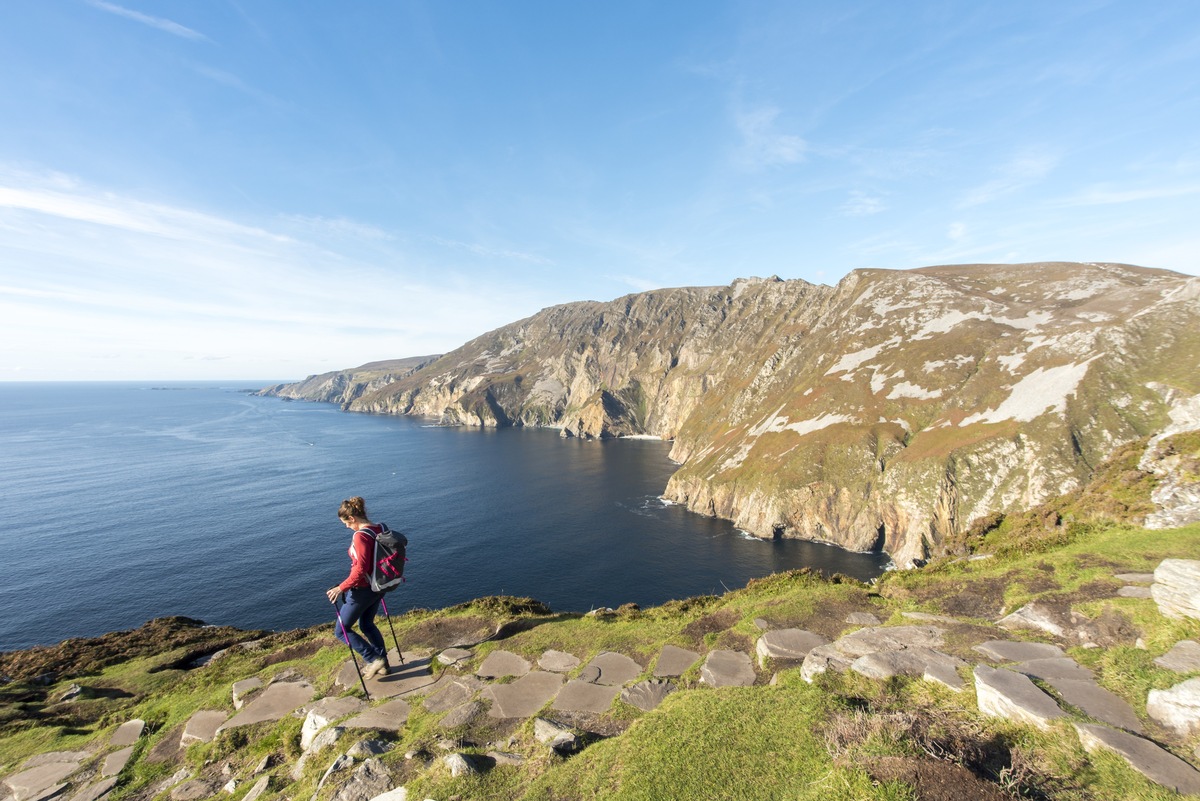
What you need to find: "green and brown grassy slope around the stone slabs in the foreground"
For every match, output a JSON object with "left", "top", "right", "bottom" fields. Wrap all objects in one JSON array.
[{"left": 0, "top": 438, "right": 1200, "bottom": 801}]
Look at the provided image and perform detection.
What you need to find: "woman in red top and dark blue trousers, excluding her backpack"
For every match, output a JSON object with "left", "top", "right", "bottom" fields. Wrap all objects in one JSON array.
[{"left": 325, "top": 498, "right": 388, "bottom": 679}]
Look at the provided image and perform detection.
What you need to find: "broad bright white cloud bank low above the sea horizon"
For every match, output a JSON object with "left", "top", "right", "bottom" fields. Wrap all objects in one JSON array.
[{"left": 0, "top": 167, "right": 565, "bottom": 380}]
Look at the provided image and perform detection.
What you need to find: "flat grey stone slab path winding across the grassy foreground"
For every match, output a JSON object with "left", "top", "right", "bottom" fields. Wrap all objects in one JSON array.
[{"left": 4, "top": 560, "right": 1200, "bottom": 801}]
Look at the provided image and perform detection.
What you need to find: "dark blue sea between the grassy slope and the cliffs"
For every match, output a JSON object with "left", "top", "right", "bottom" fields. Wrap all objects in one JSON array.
[{"left": 0, "top": 381, "right": 887, "bottom": 651}]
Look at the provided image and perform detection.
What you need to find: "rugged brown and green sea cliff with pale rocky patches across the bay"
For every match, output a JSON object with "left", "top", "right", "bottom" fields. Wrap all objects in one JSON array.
[{"left": 262, "top": 263, "right": 1200, "bottom": 565}]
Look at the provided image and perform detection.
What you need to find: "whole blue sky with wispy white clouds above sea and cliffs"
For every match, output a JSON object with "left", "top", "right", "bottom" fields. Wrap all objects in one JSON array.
[{"left": 0, "top": 0, "right": 1200, "bottom": 380}]
